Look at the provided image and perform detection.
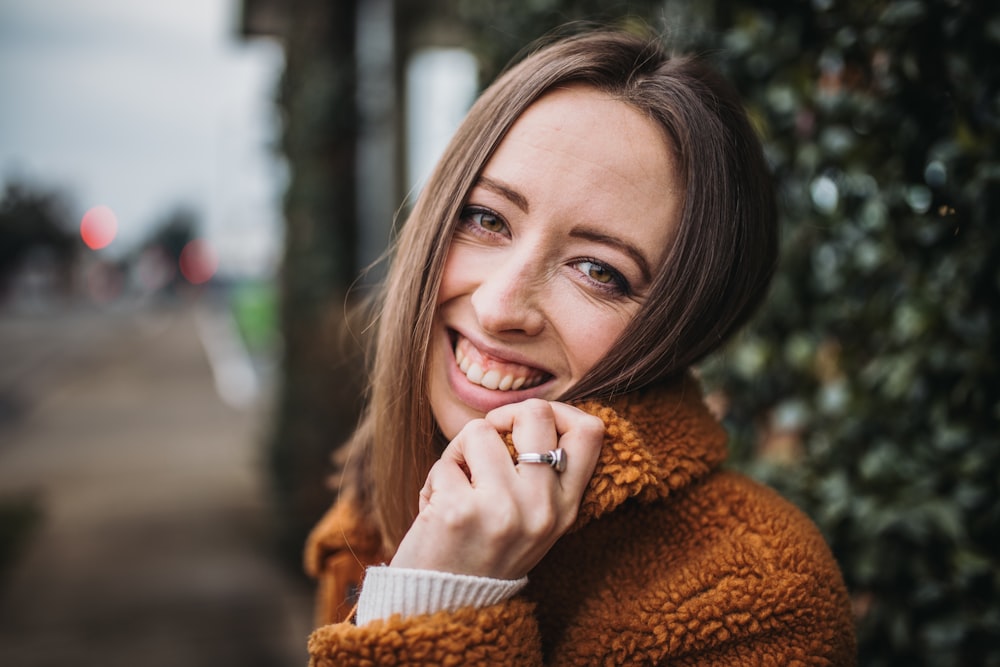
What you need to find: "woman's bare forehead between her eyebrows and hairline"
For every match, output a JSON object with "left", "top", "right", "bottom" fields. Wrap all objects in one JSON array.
[{"left": 483, "top": 85, "right": 683, "bottom": 262}]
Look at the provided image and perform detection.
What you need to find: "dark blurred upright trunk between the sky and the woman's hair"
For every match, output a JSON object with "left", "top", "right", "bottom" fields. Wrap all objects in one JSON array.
[{"left": 270, "top": 0, "right": 361, "bottom": 561}]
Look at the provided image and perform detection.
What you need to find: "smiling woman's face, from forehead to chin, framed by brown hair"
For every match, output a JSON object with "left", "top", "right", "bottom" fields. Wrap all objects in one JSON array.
[{"left": 430, "top": 86, "right": 683, "bottom": 439}]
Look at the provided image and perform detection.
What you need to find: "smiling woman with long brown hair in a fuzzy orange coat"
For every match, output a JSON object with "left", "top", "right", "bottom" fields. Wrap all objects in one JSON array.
[{"left": 306, "top": 28, "right": 854, "bottom": 665}]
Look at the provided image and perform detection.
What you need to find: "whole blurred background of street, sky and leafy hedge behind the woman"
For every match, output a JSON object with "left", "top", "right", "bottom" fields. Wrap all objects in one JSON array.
[{"left": 0, "top": 0, "right": 1000, "bottom": 666}]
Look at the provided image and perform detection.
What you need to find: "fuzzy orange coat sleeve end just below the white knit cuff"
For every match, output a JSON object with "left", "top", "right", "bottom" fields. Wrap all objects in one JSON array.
[{"left": 309, "top": 597, "right": 542, "bottom": 667}]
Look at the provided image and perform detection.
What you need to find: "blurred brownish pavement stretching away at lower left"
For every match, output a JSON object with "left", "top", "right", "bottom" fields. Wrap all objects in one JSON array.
[{"left": 0, "top": 305, "right": 311, "bottom": 667}]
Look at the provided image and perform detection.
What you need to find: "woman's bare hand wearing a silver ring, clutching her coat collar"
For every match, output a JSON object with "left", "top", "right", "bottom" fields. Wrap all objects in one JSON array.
[{"left": 390, "top": 399, "right": 604, "bottom": 579}]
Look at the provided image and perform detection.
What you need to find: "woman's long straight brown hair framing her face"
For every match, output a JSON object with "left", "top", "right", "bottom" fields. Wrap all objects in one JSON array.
[{"left": 351, "top": 32, "right": 777, "bottom": 554}]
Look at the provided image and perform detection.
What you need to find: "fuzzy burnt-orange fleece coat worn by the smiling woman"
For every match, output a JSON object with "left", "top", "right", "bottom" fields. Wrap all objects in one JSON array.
[{"left": 306, "top": 379, "right": 855, "bottom": 667}]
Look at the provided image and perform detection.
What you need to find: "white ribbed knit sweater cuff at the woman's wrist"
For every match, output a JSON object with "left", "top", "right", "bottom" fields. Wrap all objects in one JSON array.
[{"left": 355, "top": 565, "right": 528, "bottom": 626}]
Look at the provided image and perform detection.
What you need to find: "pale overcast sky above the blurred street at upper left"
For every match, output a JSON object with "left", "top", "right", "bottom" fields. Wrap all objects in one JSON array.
[{"left": 0, "top": 0, "right": 283, "bottom": 272}]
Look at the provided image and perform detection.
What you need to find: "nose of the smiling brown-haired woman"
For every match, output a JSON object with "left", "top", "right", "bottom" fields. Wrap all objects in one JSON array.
[{"left": 471, "top": 257, "right": 545, "bottom": 336}]
